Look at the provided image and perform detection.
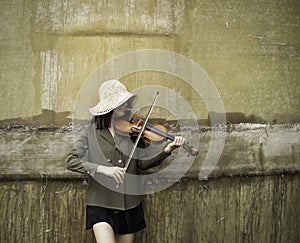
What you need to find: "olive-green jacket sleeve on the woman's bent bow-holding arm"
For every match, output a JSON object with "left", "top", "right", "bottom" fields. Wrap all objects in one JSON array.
[{"left": 66, "top": 128, "right": 98, "bottom": 176}]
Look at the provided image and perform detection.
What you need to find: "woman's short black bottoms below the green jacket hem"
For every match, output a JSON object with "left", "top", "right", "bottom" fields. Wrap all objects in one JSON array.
[{"left": 86, "top": 204, "right": 146, "bottom": 234}]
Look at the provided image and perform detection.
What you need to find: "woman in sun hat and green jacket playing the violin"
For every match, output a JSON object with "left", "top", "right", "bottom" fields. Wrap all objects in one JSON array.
[{"left": 67, "top": 80, "right": 184, "bottom": 243}]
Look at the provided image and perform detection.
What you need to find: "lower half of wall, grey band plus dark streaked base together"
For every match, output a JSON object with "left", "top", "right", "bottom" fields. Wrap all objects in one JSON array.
[{"left": 0, "top": 124, "right": 300, "bottom": 243}]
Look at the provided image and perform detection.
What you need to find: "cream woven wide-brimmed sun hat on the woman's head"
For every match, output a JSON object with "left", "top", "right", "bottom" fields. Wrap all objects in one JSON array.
[{"left": 89, "top": 80, "right": 137, "bottom": 116}]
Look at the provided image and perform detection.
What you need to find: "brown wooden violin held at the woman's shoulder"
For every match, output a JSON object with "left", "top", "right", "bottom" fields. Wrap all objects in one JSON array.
[{"left": 115, "top": 114, "right": 198, "bottom": 156}]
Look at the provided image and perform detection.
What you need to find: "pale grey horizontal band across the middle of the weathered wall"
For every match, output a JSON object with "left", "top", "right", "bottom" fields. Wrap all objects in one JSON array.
[{"left": 0, "top": 124, "right": 300, "bottom": 179}]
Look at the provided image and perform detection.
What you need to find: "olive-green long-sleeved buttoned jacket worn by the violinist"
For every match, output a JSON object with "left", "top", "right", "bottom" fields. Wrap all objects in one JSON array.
[{"left": 67, "top": 122, "right": 170, "bottom": 210}]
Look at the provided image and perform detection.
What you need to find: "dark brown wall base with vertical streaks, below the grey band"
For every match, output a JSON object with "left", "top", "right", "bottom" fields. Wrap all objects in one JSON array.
[{"left": 0, "top": 174, "right": 300, "bottom": 243}]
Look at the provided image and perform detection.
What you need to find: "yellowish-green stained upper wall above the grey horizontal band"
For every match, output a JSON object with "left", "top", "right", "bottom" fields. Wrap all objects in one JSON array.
[{"left": 0, "top": 0, "right": 300, "bottom": 125}]
